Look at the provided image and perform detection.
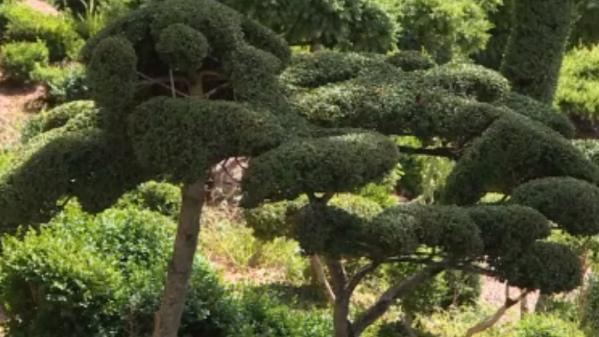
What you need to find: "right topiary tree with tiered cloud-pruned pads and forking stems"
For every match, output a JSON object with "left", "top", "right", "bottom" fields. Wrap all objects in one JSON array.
[{"left": 242, "top": 52, "right": 599, "bottom": 337}]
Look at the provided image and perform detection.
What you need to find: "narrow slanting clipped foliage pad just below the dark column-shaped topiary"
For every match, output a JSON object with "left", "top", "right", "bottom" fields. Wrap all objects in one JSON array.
[{"left": 501, "top": 92, "right": 576, "bottom": 138}]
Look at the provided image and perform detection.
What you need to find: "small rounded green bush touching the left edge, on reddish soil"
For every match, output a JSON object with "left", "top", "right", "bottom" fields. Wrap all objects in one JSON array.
[{"left": 0, "top": 41, "right": 48, "bottom": 82}]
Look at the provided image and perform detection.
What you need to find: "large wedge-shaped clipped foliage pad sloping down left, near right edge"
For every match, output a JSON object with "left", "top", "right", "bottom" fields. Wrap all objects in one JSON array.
[{"left": 444, "top": 114, "right": 599, "bottom": 205}]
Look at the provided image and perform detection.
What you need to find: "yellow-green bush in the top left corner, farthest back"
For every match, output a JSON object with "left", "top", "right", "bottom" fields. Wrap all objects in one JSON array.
[{"left": 0, "top": 3, "right": 83, "bottom": 62}]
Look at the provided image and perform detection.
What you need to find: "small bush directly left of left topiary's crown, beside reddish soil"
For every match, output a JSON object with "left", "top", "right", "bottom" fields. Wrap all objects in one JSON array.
[{"left": 31, "top": 64, "right": 90, "bottom": 105}]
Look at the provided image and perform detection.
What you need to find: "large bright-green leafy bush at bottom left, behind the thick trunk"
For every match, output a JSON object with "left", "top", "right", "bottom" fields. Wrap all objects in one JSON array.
[{"left": 0, "top": 205, "right": 235, "bottom": 337}]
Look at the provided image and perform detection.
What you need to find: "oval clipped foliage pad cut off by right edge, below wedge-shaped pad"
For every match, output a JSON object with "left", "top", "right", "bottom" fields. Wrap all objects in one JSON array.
[{"left": 511, "top": 178, "right": 599, "bottom": 236}]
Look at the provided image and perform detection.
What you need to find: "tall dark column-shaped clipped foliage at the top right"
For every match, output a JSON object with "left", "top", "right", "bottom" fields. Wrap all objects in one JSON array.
[{"left": 501, "top": 0, "right": 575, "bottom": 103}]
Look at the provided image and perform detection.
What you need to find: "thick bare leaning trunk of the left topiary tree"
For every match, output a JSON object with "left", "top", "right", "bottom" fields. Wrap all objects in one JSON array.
[{"left": 153, "top": 178, "right": 205, "bottom": 337}]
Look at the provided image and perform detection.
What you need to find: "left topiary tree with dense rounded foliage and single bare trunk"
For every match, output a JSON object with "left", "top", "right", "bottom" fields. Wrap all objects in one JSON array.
[{"left": 0, "top": 0, "right": 306, "bottom": 337}]
